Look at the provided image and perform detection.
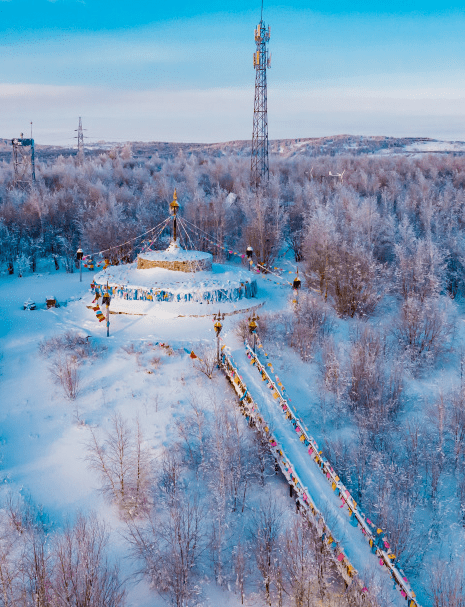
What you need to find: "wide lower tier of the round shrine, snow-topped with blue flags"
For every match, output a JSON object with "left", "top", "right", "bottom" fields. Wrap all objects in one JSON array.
[{"left": 93, "top": 264, "right": 257, "bottom": 304}]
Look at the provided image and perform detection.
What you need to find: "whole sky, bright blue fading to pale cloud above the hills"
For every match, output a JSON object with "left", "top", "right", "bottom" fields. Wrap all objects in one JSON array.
[{"left": 0, "top": 0, "right": 465, "bottom": 145}]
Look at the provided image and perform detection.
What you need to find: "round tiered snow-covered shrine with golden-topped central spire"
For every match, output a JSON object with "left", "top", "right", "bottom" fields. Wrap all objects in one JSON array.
[{"left": 92, "top": 190, "right": 257, "bottom": 309}]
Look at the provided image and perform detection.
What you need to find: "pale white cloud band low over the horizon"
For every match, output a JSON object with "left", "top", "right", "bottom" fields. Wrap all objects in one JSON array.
[{"left": 0, "top": 84, "right": 465, "bottom": 145}]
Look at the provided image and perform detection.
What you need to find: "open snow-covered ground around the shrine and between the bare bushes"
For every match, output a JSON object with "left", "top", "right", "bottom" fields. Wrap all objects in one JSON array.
[{"left": 0, "top": 264, "right": 465, "bottom": 607}]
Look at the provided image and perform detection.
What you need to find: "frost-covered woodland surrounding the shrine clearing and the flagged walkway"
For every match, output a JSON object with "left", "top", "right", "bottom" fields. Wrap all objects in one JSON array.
[{"left": 0, "top": 145, "right": 465, "bottom": 607}]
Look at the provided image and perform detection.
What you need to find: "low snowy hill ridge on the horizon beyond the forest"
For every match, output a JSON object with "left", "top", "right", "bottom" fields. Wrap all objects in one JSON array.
[{"left": 0, "top": 135, "right": 465, "bottom": 162}]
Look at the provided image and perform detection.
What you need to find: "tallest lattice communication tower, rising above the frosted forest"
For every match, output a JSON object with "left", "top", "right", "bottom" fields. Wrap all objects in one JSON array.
[{"left": 251, "top": 3, "right": 271, "bottom": 187}]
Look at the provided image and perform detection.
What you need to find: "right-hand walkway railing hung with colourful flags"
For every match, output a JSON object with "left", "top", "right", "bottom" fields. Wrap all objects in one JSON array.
[{"left": 244, "top": 342, "right": 418, "bottom": 607}]
